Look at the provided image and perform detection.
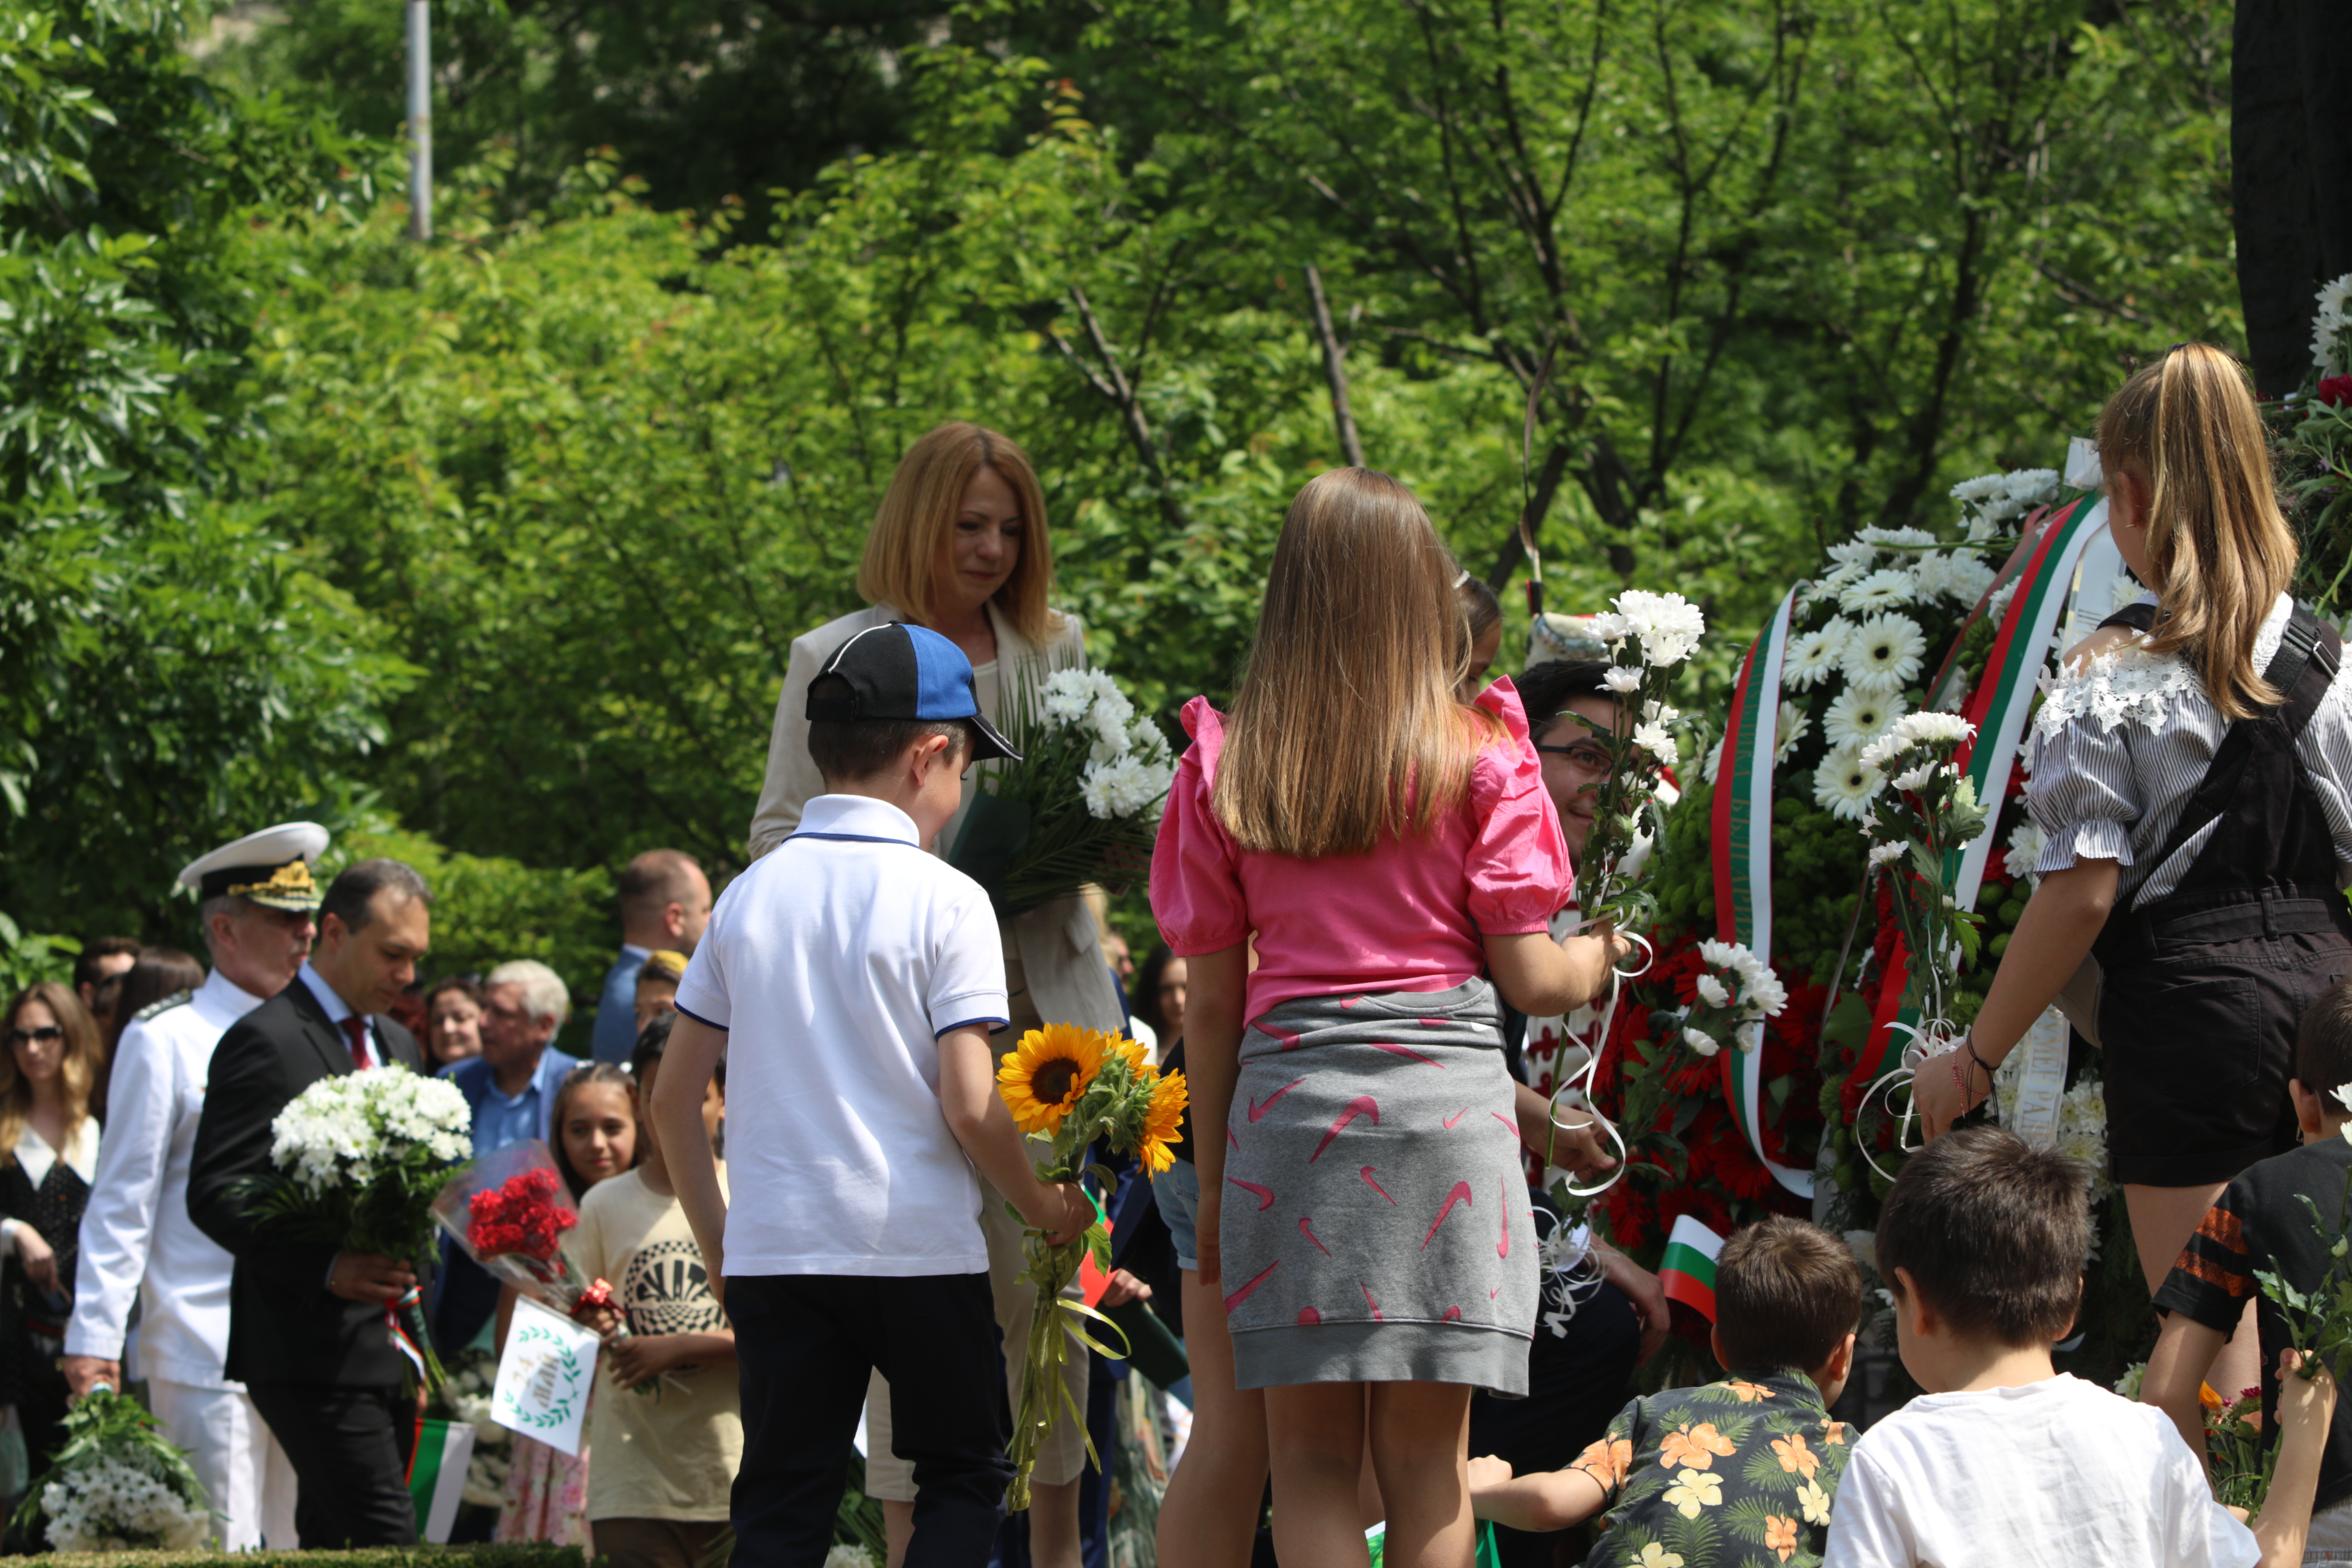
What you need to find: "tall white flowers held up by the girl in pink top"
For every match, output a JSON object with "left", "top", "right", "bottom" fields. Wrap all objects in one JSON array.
[{"left": 1564, "top": 588, "right": 1708, "bottom": 931}]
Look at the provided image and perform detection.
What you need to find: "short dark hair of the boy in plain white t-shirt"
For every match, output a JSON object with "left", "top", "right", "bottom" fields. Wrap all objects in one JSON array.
[{"left": 1872, "top": 1126, "right": 2091, "bottom": 1349}]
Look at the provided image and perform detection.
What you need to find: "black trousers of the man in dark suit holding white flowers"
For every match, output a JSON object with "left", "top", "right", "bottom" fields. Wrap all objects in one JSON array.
[{"left": 245, "top": 1382, "right": 416, "bottom": 1552}]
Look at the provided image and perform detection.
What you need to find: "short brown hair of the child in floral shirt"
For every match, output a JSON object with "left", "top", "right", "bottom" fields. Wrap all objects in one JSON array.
[{"left": 1715, "top": 1213, "right": 1863, "bottom": 1373}]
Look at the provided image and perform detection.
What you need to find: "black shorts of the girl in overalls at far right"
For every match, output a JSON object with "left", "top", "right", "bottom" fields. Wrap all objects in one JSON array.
[{"left": 2098, "top": 912, "right": 2352, "bottom": 1187}]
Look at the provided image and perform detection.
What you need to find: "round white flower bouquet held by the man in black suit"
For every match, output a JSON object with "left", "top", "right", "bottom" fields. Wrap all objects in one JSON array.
[{"left": 249, "top": 1067, "right": 473, "bottom": 1406}]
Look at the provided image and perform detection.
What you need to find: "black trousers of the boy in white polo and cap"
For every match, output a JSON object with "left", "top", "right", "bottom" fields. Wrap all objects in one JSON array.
[{"left": 727, "top": 1274, "right": 1014, "bottom": 1568}]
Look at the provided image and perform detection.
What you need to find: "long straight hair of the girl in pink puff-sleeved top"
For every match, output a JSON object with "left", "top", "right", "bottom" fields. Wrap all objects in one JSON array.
[{"left": 1209, "top": 468, "right": 1496, "bottom": 858}]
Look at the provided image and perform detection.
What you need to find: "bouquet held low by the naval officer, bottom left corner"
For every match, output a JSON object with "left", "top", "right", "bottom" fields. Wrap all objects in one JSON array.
[{"left": 16, "top": 1387, "right": 211, "bottom": 1552}]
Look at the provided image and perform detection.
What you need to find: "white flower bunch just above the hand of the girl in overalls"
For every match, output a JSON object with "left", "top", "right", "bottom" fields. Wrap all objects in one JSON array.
[{"left": 1858, "top": 712, "right": 1988, "bottom": 1034}]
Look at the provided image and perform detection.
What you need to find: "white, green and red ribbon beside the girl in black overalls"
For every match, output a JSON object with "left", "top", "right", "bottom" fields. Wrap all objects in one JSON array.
[{"left": 1853, "top": 494, "right": 2107, "bottom": 1081}]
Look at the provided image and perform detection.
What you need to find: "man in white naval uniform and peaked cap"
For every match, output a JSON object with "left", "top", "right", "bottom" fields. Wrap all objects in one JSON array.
[{"left": 64, "top": 823, "right": 327, "bottom": 1552}]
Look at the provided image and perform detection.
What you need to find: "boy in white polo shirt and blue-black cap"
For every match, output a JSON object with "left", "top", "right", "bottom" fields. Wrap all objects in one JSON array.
[{"left": 654, "top": 623, "right": 1093, "bottom": 1568}]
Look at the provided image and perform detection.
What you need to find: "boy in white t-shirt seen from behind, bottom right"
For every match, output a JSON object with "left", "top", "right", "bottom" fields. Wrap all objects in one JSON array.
[{"left": 1823, "top": 1126, "right": 2336, "bottom": 1568}]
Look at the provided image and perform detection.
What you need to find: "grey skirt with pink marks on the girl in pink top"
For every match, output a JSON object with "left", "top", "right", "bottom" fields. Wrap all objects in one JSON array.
[{"left": 1218, "top": 980, "right": 1538, "bottom": 1394}]
